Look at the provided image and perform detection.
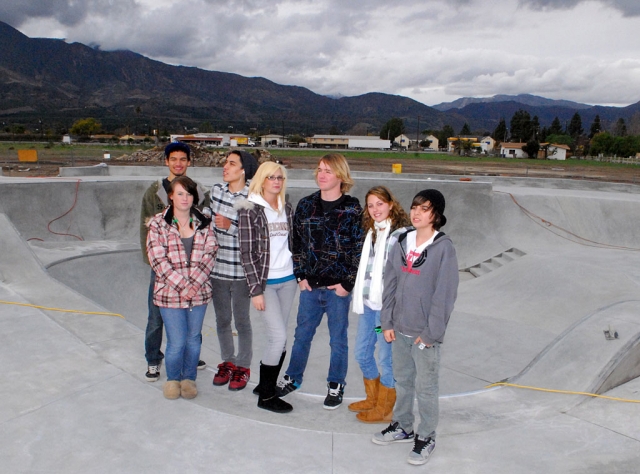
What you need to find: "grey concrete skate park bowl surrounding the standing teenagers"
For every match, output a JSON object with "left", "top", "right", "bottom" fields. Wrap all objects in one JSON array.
[{"left": 0, "top": 162, "right": 640, "bottom": 474}]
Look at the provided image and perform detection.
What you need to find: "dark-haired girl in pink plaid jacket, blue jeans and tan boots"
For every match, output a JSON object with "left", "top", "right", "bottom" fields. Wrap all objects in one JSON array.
[{"left": 147, "top": 176, "right": 218, "bottom": 399}]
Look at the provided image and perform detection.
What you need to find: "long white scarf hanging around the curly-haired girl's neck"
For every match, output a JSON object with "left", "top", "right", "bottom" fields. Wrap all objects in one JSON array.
[{"left": 352, "top": 219, "right": 391, "bottom": 314}]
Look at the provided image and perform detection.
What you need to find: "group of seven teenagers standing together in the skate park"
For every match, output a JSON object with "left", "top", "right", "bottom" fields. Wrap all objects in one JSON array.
[{"left": 140, "top": 142, "right": 458, "bottom": 464}]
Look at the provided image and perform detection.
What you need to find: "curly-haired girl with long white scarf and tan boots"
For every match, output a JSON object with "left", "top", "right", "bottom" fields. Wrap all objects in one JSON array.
[{"left": 349, "top": 186, "right": 409, "bottom": 423}]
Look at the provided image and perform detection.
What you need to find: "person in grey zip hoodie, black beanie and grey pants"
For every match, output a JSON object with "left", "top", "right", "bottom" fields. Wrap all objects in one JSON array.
[{"left": 372, "top": 189, "right": 458, "bottom": 464}]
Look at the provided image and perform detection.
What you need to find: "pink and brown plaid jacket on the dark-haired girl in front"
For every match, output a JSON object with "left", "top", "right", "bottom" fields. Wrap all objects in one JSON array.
[{"left": 147, "top": 207, "right": 218, "bottom": 308}]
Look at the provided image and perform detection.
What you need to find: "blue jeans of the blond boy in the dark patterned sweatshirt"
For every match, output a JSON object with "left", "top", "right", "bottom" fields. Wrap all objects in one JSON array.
[{"left": 286, "top": 289, "right": 351, "bottom": 384}]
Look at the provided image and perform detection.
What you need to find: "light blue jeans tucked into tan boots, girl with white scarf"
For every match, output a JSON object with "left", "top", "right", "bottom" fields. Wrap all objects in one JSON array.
[{"left": 355, "top": 304, "right": 395, "bottom": 388}]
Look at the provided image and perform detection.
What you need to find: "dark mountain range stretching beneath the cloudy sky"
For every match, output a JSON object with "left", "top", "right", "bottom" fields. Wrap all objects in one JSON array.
[{"left": 0, "top": 22, "right": 640, "bottom": 136}]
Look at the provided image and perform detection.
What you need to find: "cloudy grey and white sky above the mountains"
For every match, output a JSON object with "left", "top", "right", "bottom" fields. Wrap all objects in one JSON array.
[{"left": 0, "top": 0, "right": 640, "bottom": 106}]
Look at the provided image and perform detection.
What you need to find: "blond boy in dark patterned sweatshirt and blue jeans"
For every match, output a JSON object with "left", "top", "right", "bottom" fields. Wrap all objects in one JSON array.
[{"left": 278, "top": 153, "right": 362, "bottom": 410}]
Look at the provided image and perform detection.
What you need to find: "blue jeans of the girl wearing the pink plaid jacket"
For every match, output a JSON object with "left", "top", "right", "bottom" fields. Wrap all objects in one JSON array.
[{"left": 160, "top": 304, "right": 207, "bottom": 381}]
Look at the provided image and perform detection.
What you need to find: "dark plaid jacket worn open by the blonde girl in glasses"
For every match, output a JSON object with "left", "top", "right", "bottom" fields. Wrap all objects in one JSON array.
[{"left": 238, "top": 200, "right": 293, "bottom": 296}]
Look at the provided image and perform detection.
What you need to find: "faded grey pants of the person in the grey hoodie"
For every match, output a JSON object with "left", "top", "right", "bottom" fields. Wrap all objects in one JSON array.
[{"left": 392, "top": 331, "right": 440, "bottom": 438}]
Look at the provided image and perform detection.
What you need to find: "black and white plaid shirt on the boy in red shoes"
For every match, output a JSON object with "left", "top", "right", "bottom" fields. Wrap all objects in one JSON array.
[{"left": 210, "top": 181, "right": 249, "bottom": 280}]
